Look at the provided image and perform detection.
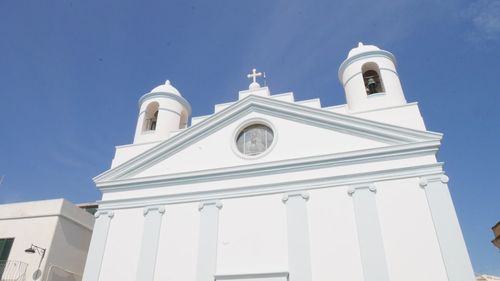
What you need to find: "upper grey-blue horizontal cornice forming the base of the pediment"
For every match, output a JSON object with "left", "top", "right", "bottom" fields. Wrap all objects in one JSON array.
[{"left": 97, "top": 141, "right": 440, "bottom": 190}]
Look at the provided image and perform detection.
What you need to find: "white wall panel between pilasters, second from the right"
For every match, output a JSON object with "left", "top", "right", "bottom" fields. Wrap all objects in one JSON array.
[{"left": 307, "top": 186, "right": 363, "bottom": 281}]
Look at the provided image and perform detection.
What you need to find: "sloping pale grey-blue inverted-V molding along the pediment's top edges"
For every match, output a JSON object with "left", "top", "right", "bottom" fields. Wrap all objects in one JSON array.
[{"left": 94, "top": 95, "right": 442, "bottom": 184}]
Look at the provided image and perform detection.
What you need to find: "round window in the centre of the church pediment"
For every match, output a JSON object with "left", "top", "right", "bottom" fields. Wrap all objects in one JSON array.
[{"left": 236, "top": 124, "right": 274, "bottom": 156}]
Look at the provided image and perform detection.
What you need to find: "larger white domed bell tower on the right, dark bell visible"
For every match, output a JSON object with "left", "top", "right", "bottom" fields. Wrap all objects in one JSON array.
[{"left": 339, "top": 42, "right": 406, "bottom": 112}]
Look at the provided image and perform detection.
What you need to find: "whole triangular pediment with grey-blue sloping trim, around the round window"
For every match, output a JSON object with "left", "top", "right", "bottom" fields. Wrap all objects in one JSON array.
[{"left": 94, "top": 95, "right": 441, "bottom": 185}]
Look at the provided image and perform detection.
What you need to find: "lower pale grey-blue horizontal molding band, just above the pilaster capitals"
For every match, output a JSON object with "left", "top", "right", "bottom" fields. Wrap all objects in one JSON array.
[{"left": 97, "top": 163, "right": 443, "bottom": 210}]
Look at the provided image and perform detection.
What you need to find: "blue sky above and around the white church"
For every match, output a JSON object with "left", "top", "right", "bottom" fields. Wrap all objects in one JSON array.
[{"left": 0, "top": 0, "right": 500, "bottom": 275}]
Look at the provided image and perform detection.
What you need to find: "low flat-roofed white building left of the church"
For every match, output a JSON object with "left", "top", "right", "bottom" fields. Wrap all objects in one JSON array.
[{"left": 0, "top": 199, "right": 94, "bottom": 281}]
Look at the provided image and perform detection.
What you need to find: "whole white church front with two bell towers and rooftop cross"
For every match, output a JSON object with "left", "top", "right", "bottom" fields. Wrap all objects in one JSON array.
[{"left": 83, "top": 43, "right": 474, "bottom": 281}]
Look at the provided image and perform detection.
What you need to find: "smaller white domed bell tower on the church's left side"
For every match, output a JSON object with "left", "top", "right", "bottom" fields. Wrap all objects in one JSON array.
[{"left": 134, "top": 80, "right": 191, "bottom": 144}]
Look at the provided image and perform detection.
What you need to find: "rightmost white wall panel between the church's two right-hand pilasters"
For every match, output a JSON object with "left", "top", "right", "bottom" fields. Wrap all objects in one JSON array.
[{"left": 375, "top": 178, "right": 447, "bottom": 281}]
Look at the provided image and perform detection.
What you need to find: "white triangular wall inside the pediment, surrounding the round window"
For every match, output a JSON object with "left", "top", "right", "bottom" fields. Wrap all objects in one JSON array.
[{"left": 135, "top": 110, "right": 387, "bottom": 177}]
